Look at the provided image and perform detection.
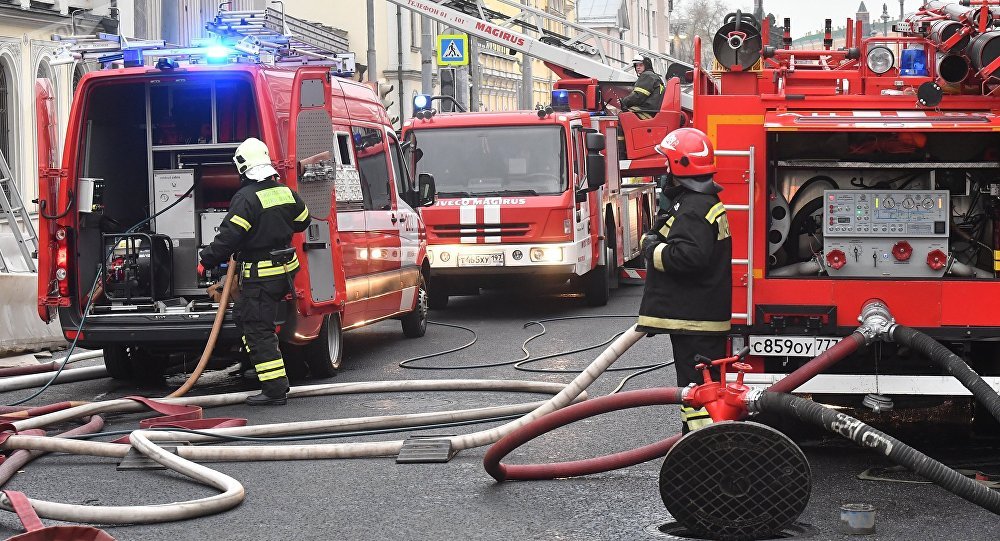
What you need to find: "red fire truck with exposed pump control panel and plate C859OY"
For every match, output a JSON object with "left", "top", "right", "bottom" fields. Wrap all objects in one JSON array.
[{"left": 694, "top": 6, "right": 1000, "bottom": 408}]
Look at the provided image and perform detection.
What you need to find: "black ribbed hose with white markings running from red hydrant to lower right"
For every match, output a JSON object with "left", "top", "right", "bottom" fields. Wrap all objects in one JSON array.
[{"left": 756, "top": 392, "right": 1000, "bottom": 515}]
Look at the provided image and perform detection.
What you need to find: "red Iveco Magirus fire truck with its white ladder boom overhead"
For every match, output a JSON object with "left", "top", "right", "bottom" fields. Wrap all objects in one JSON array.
[{"left": 389, "top": 0, "right": 690, "bottom": 307}]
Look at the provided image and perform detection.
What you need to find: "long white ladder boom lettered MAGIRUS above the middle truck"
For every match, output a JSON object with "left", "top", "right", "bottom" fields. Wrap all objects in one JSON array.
[{"left": 380, "top": 0, "right": 694, "bottom": 83}]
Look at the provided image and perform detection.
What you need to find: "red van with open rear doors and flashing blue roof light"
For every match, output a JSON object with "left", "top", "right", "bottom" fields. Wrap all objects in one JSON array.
[{"left": 38, "top": 12, "right": 433, "bottom": 378}]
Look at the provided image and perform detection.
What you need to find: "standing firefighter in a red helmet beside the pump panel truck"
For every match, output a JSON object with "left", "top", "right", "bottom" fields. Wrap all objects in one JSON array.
[{"left": 637, "top": 128, "right": 733, "bottom": 432}]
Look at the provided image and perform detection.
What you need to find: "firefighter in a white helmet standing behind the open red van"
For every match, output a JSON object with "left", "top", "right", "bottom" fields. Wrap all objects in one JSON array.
[{"left": 198, "top": 137, "right": 310, "bottom": 406}]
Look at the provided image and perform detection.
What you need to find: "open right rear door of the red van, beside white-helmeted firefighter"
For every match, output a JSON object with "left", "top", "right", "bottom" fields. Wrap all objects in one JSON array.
[{"left": 285, "top": 67, "right": 346, "bottom": 313}]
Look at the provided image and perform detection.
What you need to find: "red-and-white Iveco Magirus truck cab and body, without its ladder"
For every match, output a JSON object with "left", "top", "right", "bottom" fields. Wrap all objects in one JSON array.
[{"left": 403, "top": 111, "right": 655, "bottom": 308}]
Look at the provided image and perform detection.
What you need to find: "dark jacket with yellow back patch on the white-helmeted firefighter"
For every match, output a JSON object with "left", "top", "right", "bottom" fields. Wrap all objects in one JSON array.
[{"left": 200, "top": 179, "right": 310, "bottom": 281}]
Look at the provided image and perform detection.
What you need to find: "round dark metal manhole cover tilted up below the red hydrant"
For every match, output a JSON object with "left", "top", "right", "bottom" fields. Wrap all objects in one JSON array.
[{"left": 660, "top": 421, "right": 811, "bottom": 541}]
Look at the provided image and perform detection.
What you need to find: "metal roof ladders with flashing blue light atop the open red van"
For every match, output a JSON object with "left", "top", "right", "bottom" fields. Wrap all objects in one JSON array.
[{"left": 52, "top": 8, "right": 356, "bottom": 73}]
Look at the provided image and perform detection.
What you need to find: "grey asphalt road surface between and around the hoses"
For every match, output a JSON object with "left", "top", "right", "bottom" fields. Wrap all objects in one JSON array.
[{"left": 0, "top": 287, "right": 1000, "bottom": 541}]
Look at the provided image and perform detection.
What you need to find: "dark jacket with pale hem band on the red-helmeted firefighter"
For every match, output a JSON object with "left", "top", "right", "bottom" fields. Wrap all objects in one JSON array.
[{"left": 637, "top": 188, "right": 733, "bottom": 334}]
